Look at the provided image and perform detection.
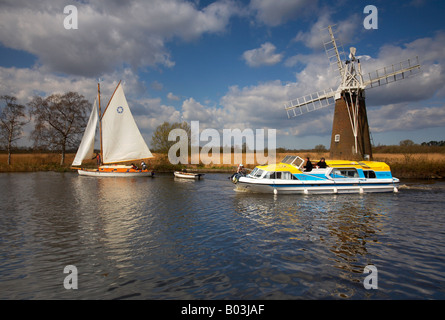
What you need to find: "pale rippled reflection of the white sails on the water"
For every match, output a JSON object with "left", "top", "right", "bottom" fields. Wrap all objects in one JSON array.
[{"left": 72, "top": 177, "right": 160, "bottom": 297}]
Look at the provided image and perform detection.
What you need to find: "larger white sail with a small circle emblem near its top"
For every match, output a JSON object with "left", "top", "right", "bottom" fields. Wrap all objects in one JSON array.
[{"left": 102, "top": 83, "right": 153, "bottom": 163}]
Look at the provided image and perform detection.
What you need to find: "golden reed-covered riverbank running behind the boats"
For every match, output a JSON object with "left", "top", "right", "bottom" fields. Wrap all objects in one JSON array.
[{"left": 0, "top": 152, "right": 445, "bottom": 179}]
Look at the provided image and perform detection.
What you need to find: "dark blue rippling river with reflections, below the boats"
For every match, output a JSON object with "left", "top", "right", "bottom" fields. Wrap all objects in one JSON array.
[{"left": 0, "top": 172, "right": 445, "bottom": 300}]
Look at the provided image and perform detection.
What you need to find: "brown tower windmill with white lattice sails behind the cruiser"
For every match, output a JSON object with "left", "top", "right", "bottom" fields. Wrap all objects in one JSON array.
[{"left": 285, "top": 26, "right": 420, "bottom": 159}]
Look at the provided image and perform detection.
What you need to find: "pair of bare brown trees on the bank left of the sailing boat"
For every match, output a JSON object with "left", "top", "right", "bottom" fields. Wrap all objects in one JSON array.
[{"left": 0, "top": 91, "right": 92, "bottom": 165}]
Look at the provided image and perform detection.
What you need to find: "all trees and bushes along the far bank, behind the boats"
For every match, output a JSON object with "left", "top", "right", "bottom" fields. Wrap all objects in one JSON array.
[{"left": 0, "top": 92, "right": 445, "bottom": 165}]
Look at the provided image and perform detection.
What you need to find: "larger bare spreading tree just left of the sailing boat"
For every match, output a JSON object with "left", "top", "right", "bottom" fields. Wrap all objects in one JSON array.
[{"left": 29, "top": 92, "right": 91, "bottom": 165}]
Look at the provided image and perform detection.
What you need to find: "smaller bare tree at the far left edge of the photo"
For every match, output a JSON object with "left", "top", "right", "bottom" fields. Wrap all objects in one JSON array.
[{"left": 0, "top": 95, "right": 28, "bottom": 165}]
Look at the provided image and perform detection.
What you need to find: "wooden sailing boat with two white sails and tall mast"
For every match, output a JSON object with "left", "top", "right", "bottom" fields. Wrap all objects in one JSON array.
[{"left": 72, "top": 82, "right": 153, "bottom": 177}]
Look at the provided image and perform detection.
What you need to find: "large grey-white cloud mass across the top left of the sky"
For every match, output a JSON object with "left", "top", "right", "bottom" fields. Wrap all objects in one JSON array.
[{"left": 0, "top": 0, "right": 237, "bottom": 77}]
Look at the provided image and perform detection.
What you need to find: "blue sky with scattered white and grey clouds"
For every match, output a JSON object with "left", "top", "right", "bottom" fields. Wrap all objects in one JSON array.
[{"left": 0, "top": 0, "right": 445, "bottom": 149}]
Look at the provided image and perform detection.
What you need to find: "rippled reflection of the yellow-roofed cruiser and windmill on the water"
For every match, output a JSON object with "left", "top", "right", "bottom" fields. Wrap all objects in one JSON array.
[{"left": 229, "top": 190, "right": 394, "bottom": 298}]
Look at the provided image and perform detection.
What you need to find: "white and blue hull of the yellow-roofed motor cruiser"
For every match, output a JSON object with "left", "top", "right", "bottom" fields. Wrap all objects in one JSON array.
[{"left": 235, "top": 177, "right": 399, "bottom": 194}]
